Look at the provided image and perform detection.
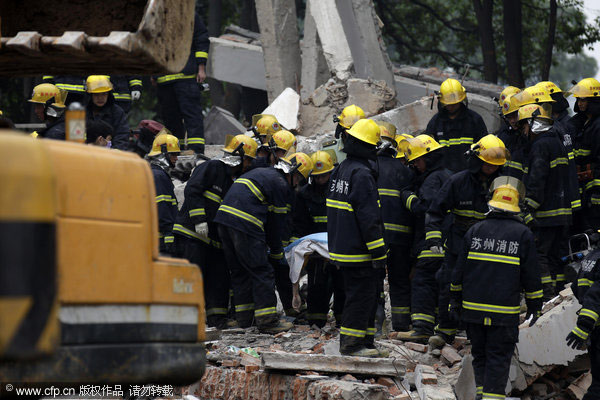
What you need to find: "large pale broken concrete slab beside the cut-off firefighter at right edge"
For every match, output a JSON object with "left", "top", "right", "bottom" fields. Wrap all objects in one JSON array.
[{"left": 517, "top": 296, "right": 585, "bottom": 366}]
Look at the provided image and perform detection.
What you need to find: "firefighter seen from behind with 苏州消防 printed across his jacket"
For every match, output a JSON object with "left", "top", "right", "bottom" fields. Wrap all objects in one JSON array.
[{"left": 450, "top": 176, "right": 542, "bottom": 400}]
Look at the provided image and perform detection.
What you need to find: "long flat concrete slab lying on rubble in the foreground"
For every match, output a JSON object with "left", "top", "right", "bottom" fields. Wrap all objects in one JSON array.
[{"left": 261, "top": 352, "right": 404, "bottom": 376}]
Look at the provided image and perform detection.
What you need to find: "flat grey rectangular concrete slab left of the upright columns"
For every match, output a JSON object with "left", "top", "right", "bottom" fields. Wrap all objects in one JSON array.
[{"left": 207, "top": 37, "right": 267, "bottom": 90}]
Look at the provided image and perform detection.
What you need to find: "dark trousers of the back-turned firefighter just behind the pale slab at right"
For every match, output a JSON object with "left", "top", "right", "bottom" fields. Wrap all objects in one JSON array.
[{"left": 536, "top": 226, "right": 568, "bottom": 300}]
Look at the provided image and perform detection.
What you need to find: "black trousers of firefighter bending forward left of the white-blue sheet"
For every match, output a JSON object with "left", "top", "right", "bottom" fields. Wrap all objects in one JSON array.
[{"left": 219, "top": 225, "right": 278, "bottom": 328}]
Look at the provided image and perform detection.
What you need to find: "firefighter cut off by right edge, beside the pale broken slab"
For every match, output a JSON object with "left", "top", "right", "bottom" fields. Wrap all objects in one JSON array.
[{"left": 567, "top": 244, "right": 600, "bottom": 400}]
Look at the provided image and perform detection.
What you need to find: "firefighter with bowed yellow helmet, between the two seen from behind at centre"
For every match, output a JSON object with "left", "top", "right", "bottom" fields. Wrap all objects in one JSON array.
[{"left": 398, "top": 135, "right": 451, "bottom": 342}]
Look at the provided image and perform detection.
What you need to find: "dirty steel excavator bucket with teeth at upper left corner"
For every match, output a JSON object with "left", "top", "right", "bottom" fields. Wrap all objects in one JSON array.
[{"left": 0, "top": 0, "right": 195, "bottom": 77}]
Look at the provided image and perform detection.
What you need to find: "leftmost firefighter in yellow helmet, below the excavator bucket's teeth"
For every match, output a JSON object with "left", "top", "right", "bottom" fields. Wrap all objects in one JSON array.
[{"left": 28, "top": 83, "right": 67, "bottom": 140}]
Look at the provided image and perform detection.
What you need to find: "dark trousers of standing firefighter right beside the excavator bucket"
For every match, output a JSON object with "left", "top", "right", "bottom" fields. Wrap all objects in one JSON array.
[{"left": 158, "top": 79, "right": 204, "bottom": 153}]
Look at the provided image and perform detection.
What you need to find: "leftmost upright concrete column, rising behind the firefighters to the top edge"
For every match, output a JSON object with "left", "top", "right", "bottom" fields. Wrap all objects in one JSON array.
[{"left": 256, "top": 0, "right": 301, "bottom": 102}]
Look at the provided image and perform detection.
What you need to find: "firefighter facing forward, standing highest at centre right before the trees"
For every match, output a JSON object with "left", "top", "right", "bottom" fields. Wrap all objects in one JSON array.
[{"left": 425, "top": 78, "right": 487, "bottom": 172}]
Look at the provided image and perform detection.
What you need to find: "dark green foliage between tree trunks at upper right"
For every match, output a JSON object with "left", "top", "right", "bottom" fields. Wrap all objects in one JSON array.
[{"left": 375, "top": 0, "right": 600, "bottom": 80}]
